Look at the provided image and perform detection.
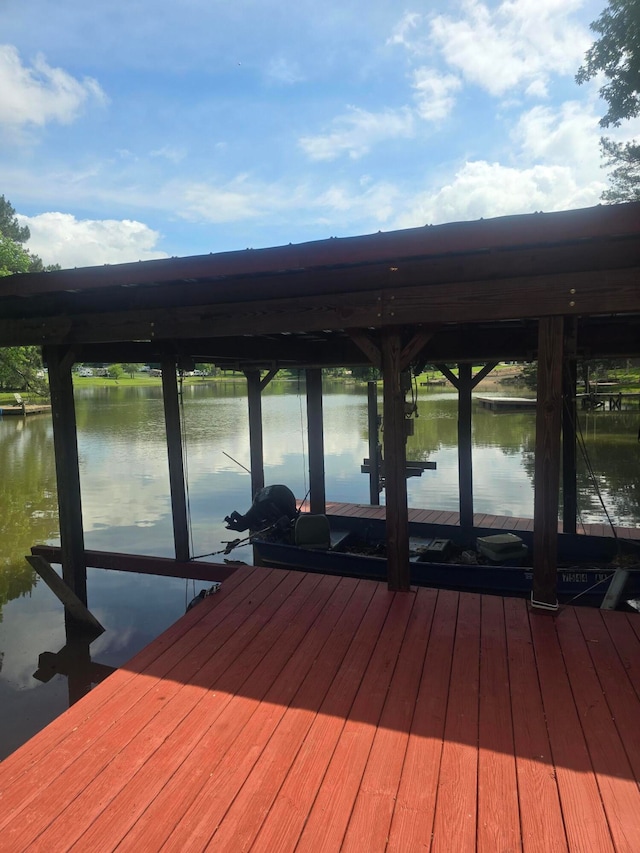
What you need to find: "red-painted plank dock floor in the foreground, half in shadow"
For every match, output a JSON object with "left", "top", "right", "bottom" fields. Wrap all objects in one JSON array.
[{"left": 0, "top": 567, "right": 640, "bottom": 853}]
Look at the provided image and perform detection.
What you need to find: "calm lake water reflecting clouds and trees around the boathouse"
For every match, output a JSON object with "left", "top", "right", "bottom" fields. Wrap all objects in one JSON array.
[{"left": 0, "top": 381, "right": 640, "bottom": 759}]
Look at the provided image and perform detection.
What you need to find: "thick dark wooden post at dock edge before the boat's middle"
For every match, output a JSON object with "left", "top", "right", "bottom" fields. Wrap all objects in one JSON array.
[{"left": 382, "top": 329, "right": 410, "bottom": 591}]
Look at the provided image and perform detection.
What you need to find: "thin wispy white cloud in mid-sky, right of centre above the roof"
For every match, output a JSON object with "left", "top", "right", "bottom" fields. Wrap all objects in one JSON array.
[{"left": 300, "top": 107, "right": 414, "bottom": 160}]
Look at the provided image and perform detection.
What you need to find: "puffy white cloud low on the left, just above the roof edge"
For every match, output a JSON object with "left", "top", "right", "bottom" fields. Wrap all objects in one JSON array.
[{"left": 18, "top": 213, "right": 167, "bottom": 269}]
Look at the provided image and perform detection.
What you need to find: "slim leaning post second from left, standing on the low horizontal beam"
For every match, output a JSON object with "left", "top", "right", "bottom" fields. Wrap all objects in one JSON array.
[{"left": 161, "top": 355, "right": 190, "bottom": 561}]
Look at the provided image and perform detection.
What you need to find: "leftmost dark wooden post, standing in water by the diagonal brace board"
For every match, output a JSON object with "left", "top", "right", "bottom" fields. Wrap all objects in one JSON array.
[{"left": 43, "top": 346, "right": 87, "bottom": 607}]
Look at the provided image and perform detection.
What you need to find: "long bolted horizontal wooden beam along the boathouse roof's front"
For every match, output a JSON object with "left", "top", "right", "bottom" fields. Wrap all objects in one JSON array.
[{"left": 0, "top": 267, "right": 640, "bottom": 346}]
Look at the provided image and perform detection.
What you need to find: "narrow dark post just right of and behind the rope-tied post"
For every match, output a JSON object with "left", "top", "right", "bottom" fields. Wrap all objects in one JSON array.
[{"left": 562, "top": 318, "right": 578, "bottom": 533}]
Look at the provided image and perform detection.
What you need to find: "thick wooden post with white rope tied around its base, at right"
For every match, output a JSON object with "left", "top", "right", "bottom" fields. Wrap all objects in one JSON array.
[{"left": 531, "top": 317, "right": 564, "bottom": 610}]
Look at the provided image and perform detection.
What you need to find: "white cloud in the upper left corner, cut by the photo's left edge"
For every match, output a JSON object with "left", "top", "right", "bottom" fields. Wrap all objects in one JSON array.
[{"left": 0, "top": 44, "right": 106, "bottom": 129}]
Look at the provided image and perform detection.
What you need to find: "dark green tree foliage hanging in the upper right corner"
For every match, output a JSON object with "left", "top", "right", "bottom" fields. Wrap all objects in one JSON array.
[{"left": 576, "top": 0, "right": 640, "bottom": 202}]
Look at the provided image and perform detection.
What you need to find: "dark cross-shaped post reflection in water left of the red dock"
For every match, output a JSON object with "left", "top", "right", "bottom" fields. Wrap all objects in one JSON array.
[{"left": 33, "top": 619, "right": 115, "bottom": 706}]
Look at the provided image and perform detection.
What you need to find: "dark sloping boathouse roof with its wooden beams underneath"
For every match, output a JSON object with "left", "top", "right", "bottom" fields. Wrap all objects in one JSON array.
[{"left": 0, "top": 203, "right": 640, "bottom": 367}]
